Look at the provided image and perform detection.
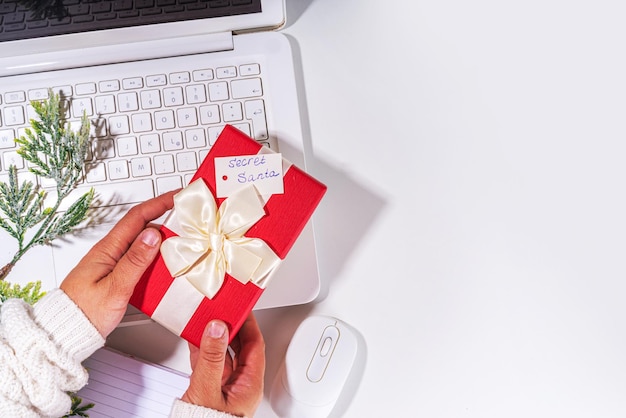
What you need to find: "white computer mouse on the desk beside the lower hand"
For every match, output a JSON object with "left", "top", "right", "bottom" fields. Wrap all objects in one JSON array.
[{"left": 270, "top": 315, "right": 358, "bottom": 418}]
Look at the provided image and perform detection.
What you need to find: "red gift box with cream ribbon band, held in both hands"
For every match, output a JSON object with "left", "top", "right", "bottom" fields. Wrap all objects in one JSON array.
[{"left": 130, "top": 125, "right": 326, "bottom": 346}]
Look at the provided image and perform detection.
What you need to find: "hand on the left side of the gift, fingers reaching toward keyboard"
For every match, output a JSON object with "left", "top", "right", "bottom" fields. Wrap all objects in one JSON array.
[{"left": 60, "top": 191, "right": 176, "bottom": 338}]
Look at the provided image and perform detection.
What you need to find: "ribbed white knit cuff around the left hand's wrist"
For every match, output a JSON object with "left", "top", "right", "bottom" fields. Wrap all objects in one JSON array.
[{"left": 33, "top": 289, "right": 105, "bottom": 362}]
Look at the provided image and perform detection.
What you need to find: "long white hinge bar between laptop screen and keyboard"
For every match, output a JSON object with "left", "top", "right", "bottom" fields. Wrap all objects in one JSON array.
[{"left": 0, "top": 32, "right": 233, "bottom": 77}]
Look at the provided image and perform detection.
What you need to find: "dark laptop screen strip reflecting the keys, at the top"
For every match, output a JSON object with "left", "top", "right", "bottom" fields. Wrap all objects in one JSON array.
[{"left": 0, "top": 0, "right": 261, "bottom": 42}]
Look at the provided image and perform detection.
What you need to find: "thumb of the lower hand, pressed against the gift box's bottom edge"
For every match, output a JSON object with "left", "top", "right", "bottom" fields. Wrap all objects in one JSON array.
[{"left": 182, "top": 320, "right": 228, "bottom": 407}]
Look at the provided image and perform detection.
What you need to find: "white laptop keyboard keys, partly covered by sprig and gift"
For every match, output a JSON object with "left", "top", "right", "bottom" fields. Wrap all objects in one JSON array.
[{"left": 0, "top": 56, "right": 276, "bottom": 209}]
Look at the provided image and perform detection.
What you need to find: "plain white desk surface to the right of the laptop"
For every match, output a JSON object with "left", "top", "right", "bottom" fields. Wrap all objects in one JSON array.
[{"left": 116, "top": 0, "right": 626, "bottom": 418}]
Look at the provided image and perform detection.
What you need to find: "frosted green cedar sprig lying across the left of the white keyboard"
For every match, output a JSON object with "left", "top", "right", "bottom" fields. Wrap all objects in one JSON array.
[{"left": 0, "top": 90, "right": 94, "bottom": 280}]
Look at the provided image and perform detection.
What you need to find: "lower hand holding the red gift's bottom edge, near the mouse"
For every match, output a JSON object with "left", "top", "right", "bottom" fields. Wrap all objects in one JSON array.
[{"left": 181, "top": 313, "right": 265, "bottom": 417}]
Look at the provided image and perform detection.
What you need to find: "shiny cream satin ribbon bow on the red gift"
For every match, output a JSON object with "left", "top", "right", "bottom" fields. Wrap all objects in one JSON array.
[{"left": 161, "top": 179, "right": 281, "bottom": 298}]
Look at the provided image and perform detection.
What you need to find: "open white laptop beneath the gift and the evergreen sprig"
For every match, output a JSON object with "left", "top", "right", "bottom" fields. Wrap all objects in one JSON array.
[{"left": 0, "top": 0, "right": 320, "bottom": 309}]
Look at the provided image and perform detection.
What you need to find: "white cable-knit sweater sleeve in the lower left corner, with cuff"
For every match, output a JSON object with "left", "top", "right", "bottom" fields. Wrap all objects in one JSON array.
[{"left": 0, "top": 289, "right": 104, "bottom": 417}]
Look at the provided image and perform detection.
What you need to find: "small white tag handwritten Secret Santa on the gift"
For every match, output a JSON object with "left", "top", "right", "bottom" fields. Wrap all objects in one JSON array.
[{"left": 215, "top": 153, "right": 284, "bottom": 197}]
